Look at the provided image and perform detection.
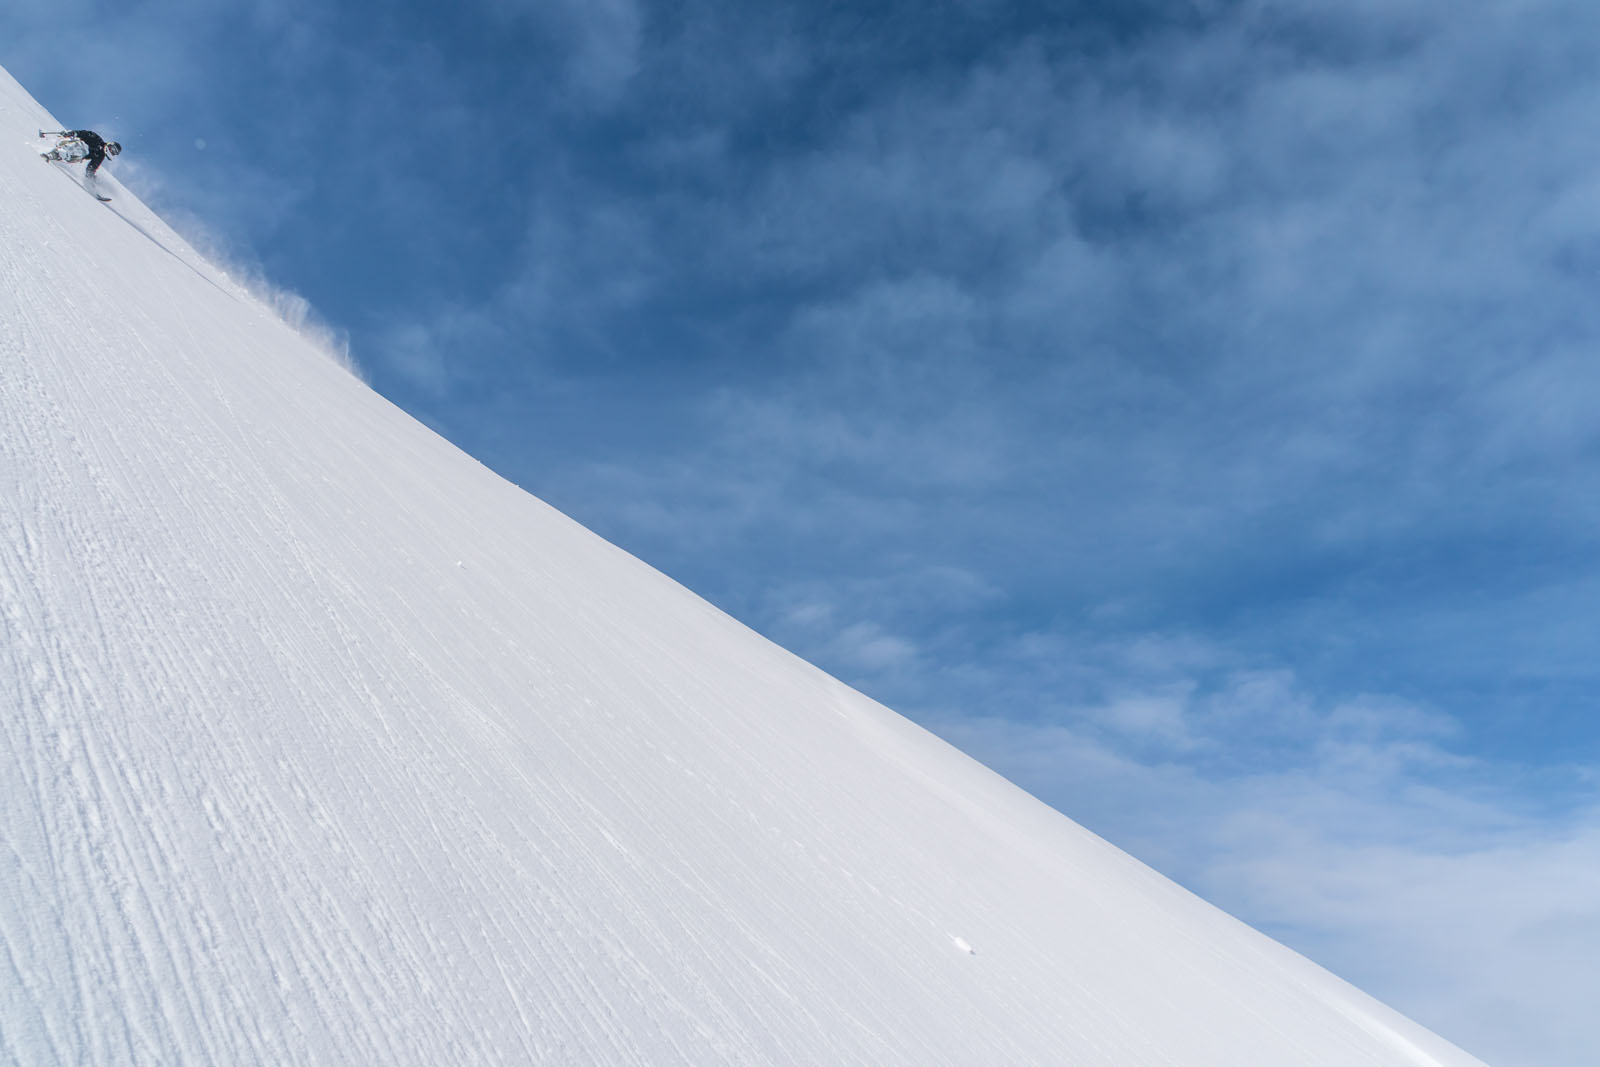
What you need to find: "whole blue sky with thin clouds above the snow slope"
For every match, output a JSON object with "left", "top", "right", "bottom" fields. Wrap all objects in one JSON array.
[{"left": 0, "top": 0, "right": 1600, "bottom": 1065}]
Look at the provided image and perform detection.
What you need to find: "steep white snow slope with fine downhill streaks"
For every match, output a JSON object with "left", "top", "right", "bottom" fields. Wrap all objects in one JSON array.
[{"left": 0, "top": 72, "right": 1477, "bottom": 1067}]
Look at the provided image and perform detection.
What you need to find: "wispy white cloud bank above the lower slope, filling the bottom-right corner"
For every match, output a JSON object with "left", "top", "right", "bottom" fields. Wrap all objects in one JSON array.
[{"left": 933, "top": 659, "right": 1600, "bottom": 1067}]
